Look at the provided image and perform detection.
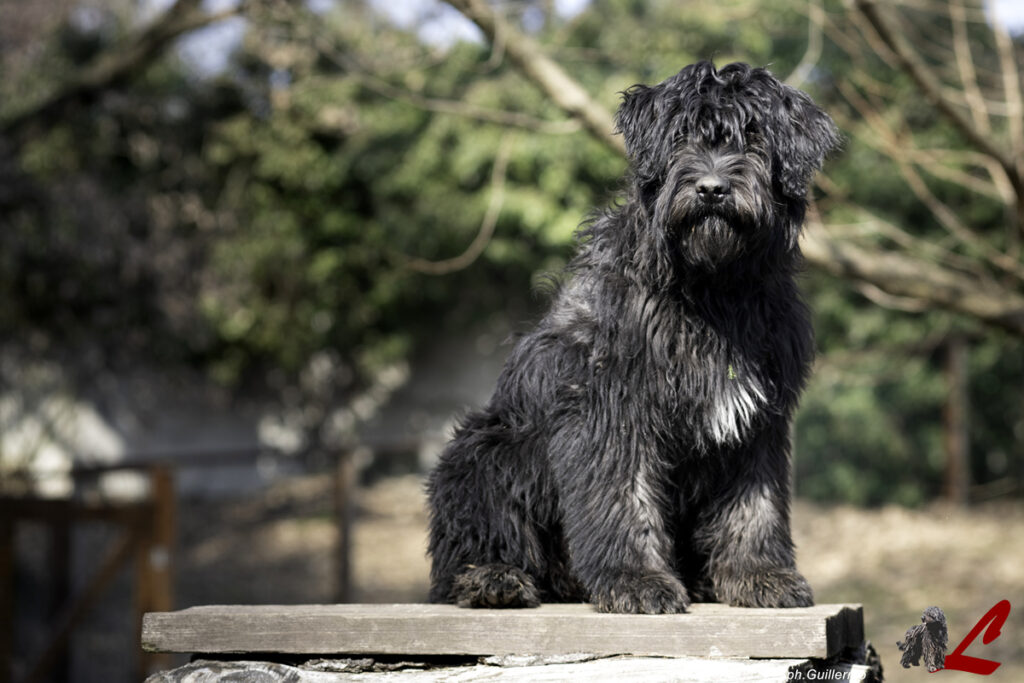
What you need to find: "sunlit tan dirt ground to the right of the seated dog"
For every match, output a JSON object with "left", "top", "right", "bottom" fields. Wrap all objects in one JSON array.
[{"left": 794, "top": 502, "right": 1024, "bottom": 683}]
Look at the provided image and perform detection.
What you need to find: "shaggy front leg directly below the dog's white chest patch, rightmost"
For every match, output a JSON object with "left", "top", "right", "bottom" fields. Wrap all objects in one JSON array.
[{"left": 696, "top": 421, "right": 814, "bottom": 607}]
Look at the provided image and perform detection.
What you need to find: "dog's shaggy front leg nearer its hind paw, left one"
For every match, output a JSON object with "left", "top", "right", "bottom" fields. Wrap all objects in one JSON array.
[{"left": 551, "top": 420, "right": 690, "bottom": 614}]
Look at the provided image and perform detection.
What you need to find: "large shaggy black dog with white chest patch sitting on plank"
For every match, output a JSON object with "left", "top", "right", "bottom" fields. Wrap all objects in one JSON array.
[{"left": 428, "top": 61, "right": 839, "bottom": 613}]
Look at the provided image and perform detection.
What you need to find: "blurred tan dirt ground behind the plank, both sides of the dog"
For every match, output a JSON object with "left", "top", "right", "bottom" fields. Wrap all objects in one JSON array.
[{"left": 172, "top": 476, "right": 1024, "bottom": 683}]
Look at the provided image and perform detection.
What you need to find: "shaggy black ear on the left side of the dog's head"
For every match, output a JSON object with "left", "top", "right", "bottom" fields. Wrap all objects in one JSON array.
[{"left": 615, "top": 85, "right": 667, "bottom": 181}]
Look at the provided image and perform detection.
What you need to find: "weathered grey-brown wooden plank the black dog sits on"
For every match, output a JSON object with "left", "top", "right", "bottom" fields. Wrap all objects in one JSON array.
[{"left": 142, "top": 604, "right": 863, "bottom": 658}]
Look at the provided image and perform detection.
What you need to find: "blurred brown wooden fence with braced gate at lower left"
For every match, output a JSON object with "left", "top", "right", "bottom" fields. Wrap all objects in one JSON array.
[{"left": 0, "top": 449, "right": 356, "bottom": 683}]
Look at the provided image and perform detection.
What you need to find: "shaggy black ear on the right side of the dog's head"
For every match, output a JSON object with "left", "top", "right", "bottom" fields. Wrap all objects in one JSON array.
[{"left": 765, "top": 86, "right": 842, "bottom": 199}]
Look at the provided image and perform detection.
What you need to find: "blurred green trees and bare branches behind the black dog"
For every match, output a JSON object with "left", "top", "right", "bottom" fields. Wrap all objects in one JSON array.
[{"left": 0, "top": 0, "right": 1024, "bottom": 505}]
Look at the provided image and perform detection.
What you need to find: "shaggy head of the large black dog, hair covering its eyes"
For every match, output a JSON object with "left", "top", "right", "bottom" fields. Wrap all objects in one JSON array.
[{"left": 615, "top": 61, "right": 840, "bottom": 268}]
